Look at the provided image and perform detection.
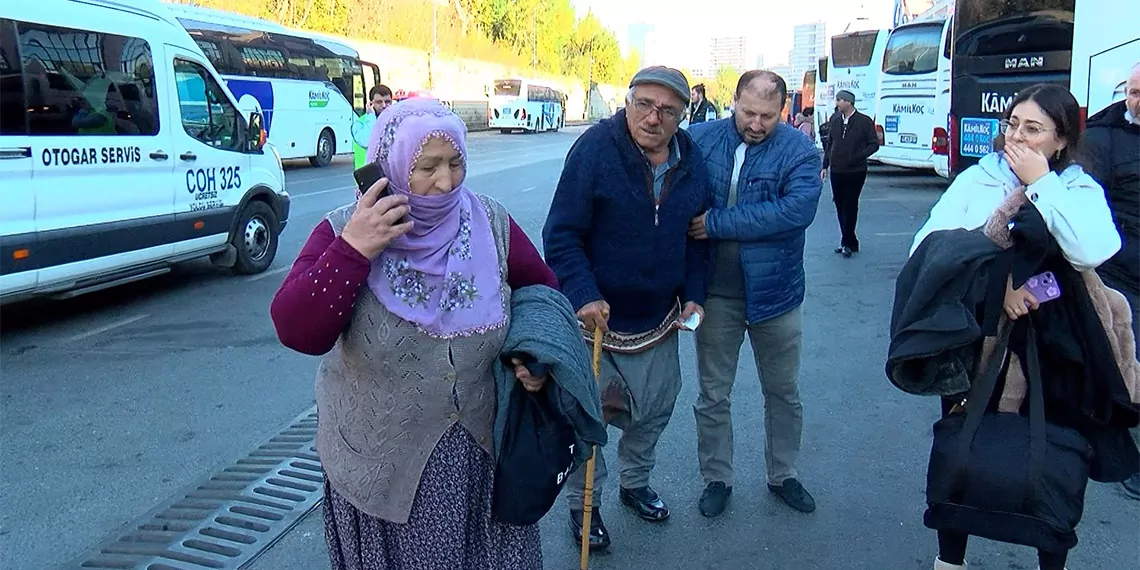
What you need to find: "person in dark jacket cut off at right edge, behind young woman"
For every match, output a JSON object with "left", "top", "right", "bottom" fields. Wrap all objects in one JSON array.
[{"left": 1081, "top": 63, "right": 1140, "bottom": 500}]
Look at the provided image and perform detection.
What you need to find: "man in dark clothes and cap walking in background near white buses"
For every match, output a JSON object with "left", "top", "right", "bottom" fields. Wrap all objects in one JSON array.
[{"left": 820, "top": 89, "right": 879, "bottom": 258}]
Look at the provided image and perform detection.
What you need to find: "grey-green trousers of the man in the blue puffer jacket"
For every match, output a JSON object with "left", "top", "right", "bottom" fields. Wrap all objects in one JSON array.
[{"left": 693, "top": 296, "right": 804, "bottom": 486}]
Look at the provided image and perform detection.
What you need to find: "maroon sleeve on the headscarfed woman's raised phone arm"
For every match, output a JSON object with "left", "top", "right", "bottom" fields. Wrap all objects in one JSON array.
[{"left": 269, "top": 220, "right": 372, "bottom": 356}]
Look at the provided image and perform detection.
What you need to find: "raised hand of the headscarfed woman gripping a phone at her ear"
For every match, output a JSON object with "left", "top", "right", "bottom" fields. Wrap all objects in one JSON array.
[{"left": 341, "top": 178, "right": 413, "bottom": 261}]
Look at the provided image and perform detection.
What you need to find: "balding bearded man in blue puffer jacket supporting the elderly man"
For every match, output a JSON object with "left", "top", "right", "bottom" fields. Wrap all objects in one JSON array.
[{"left": 690, "top": 70, "right": 822, "bottom": 516}]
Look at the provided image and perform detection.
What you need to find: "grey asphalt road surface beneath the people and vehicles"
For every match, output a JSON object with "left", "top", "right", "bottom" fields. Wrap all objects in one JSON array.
[{"left": 0, "top": 128, "right": 1140, "bottom": 570}]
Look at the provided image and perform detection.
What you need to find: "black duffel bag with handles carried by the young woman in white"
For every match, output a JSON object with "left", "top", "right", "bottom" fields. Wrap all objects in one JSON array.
[{"left": 923, "top": 317, "right": 1092, "bottom": 553}]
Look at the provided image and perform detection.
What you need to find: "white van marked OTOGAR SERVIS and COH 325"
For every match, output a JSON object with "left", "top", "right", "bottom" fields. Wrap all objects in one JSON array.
[{"left": 0, "top": 0, "right": 290, "bottom": 303}]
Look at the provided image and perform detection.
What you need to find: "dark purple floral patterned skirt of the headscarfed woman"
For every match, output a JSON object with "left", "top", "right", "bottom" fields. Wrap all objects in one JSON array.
[{"left": 325, "top": 424, "right": 543, "bottom": 570}]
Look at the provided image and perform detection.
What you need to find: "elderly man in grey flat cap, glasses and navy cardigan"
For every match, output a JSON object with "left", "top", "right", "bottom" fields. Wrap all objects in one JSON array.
[{"left": 543, "top": 67, "right": 710, "bottom": 549}]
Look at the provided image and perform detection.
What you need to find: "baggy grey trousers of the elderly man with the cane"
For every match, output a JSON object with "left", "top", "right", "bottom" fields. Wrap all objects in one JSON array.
[{"left": 565, "top": 333, "right": 681, "bottom": 510}]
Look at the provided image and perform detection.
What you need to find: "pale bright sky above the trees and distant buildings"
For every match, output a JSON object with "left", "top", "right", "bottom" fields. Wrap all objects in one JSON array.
[{"left": 571, "top": 0, "right": 895, "bottom": 67}]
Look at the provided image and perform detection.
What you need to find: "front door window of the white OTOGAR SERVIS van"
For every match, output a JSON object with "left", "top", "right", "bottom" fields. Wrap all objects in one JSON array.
[{"left": 174, "top": 59, "right": 242, "bottom": 150}]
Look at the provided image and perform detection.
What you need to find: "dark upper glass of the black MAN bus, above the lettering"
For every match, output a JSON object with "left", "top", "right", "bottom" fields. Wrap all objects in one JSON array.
[{"left": 954, "top": 0, "right": 1076, "bottom": 57}]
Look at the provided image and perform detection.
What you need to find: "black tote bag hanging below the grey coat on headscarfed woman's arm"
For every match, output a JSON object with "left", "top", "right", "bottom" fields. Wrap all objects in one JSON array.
[{"left": 491, "top": 381, "right": 575, "bottom": 526}]
